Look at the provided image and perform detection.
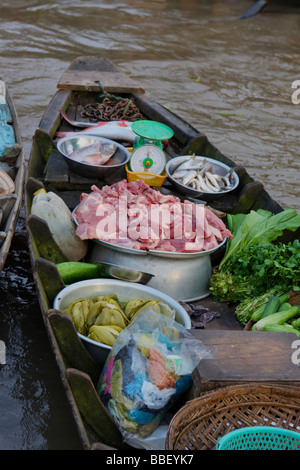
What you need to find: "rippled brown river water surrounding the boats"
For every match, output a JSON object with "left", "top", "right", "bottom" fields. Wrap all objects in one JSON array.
[{"left": 0, "top": 0, "right": 300, "bottom": 450}]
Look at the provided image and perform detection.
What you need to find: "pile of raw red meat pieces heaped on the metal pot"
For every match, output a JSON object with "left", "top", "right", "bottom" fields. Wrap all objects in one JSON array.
[{"left": 73, "top": 180, "right": 232, "bottom": 253}]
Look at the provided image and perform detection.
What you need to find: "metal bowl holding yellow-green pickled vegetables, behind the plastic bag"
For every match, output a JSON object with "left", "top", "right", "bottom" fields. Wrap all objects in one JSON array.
[{"left": 53, "top": 279, "right": 191, "bottom": 365}]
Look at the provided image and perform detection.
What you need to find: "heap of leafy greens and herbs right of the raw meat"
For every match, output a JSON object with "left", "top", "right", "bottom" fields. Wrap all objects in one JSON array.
[{"left": 210, "top": 209, "right": 300, "bottom": 303}]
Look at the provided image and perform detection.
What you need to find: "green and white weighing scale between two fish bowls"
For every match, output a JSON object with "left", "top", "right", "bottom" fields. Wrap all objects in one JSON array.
[{"left": 130, "top": 120, "right": 174, "bottom": 175}]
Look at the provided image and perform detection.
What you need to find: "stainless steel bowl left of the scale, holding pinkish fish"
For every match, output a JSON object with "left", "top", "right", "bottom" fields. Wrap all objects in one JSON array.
[{"left": 57, "top": 133, "right": 130, "bottom": 178}]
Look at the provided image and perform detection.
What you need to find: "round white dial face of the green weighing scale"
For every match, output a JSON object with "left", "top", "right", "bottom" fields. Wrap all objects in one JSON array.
[{"left": 130, "top": 144, "right": 166, "bottom": 175}]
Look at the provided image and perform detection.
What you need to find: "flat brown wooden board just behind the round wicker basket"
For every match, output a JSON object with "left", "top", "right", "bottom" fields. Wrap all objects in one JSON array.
[{"left": 189, "top": 330, "right": 300, "bottom": 399}]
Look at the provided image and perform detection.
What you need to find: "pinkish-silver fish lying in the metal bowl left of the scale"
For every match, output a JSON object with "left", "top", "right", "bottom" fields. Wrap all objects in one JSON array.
[{"left": 69, "top": 142, "right": 118, "bottom": 165}]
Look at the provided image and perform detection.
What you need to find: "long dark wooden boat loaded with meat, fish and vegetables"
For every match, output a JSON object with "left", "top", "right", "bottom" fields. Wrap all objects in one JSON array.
[{"left": 25, "top": 56, "right": 300, "bottom": 449}]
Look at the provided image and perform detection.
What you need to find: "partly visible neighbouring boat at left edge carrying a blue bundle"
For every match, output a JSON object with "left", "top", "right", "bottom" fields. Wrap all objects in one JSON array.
[{"left": 0, "top": 79, "right": 25, "bottom": 272}]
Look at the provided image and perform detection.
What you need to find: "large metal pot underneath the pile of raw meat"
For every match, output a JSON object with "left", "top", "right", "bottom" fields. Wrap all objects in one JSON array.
[{"left": 89, "top": 239, "right": 226, "bottom": 302}]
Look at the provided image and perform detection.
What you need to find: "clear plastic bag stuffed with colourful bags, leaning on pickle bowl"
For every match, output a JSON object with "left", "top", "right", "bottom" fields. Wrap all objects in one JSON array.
[{"left": 97, "top": 307, "right": 212, "bottom": 440}]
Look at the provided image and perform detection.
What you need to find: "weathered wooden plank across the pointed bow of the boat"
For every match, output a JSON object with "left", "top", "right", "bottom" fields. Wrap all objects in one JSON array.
[{"left": 57, "top": 70, "right": 145, "bottom": 93}]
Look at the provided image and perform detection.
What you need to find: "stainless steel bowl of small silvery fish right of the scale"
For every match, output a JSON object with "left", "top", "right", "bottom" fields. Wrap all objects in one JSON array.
[{"left": 166, "top": 155, "right": 239, "bottom": 201}]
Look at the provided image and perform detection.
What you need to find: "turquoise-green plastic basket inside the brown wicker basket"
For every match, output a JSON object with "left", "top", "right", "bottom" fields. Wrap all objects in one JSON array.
[{"left": 216, "top": 426, "right": 300, "bottom": 450}]
